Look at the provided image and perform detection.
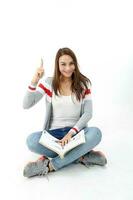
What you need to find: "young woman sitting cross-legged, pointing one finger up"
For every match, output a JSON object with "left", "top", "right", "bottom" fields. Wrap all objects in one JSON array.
[{"left": 23, "top": 48, "right": 107, "bottom": 177}]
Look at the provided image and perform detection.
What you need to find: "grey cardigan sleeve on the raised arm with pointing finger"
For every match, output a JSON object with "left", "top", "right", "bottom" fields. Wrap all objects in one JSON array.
[{"left": 23, "top": 78, "right": 48, "bottom": 109}]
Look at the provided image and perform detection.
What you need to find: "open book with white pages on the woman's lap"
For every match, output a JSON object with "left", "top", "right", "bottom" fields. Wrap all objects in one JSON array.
[{"left": 39, "top": 130, "right": 85, "bottom": 159}]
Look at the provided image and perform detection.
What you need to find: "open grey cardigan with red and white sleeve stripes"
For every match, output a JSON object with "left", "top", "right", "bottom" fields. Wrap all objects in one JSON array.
[{"left": 23, "top": 77, "right": 92, "bottom": 134}]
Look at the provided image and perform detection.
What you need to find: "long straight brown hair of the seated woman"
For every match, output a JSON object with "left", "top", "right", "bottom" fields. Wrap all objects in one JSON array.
[{"left": 52, "top": 47, "right": 91, "bottom": 101}]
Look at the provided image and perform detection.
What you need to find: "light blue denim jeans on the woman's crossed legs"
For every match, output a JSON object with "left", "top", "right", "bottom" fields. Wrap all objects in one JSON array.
[{"left": 27, "top": 127, "right": 102, "bottom": 170}]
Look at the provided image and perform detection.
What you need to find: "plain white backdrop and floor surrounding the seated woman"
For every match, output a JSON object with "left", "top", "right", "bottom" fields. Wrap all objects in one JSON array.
[{"left": 0, "top": 0, "right": 133, "bottom": 200}]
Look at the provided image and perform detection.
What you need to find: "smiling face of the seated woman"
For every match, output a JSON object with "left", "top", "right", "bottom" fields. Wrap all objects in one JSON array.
[{"left": 59, "top": 55, "right": 75, "bottom": 78}]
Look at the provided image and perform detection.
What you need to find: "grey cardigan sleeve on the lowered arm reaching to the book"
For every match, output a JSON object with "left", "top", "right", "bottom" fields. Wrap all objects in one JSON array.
[{"left": 70, "top": 81, "right": 92, "bottom": 135}]
